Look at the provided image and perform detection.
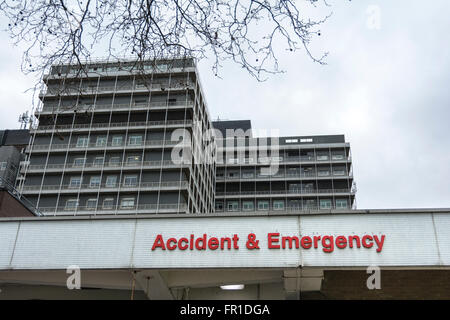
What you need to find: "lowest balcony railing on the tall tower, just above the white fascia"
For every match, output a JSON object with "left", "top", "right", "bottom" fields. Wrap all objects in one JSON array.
[{"left": 39, "top": 203, "right": 187, "bottom": 215}]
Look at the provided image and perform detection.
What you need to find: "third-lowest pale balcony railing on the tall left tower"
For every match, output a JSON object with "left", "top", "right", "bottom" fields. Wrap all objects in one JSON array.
[{"left": 24, "top": 160, "right": 186, "bottom": 171}]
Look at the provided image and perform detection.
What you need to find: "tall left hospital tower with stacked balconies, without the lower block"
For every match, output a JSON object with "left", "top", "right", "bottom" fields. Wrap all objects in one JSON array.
[{"left": 19, "top": 59, "right": 215, "bottom": 215}]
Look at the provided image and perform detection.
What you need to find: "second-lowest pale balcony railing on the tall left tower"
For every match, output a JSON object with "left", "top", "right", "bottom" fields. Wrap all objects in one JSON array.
[{"left": 22, "top": 181, "right": 188, "bottom": 193}]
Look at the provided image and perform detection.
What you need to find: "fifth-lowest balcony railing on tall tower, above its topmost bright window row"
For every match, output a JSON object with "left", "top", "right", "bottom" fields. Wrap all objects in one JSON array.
[{"left": 33, "top": 120, "right": 192, "bottom": 131}]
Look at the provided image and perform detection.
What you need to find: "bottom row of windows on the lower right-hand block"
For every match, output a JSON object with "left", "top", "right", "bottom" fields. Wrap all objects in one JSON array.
[{"left": 216, "top": 199, "right": 348, "bottom": 211}]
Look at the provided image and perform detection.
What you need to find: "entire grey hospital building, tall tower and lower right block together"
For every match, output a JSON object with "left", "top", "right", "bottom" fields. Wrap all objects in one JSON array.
[{"left": 19, "top": 59, "right": 355, "bottom": 215}]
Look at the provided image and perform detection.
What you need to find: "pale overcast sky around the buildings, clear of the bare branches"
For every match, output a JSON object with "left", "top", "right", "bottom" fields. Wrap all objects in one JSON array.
[{"left": 0, "top": 0, "right": 450, "bottom": 209}]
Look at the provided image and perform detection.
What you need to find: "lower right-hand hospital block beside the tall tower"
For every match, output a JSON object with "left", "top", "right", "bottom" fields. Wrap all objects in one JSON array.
[{"left": 213, "top": 120, "right": 355, "bottom": 212}]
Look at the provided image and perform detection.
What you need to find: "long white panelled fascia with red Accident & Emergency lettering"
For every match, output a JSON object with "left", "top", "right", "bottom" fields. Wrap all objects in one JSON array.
[{"left": 0, "top": 209, "right": 450, "bottom": 270}]
